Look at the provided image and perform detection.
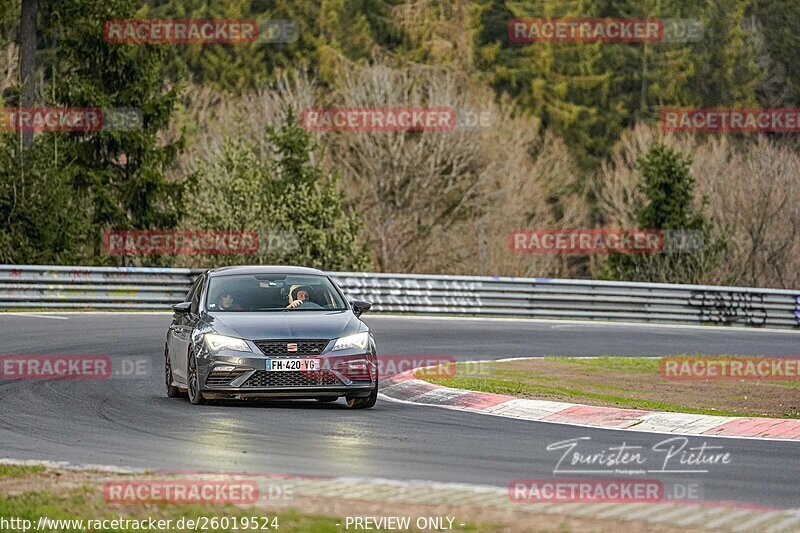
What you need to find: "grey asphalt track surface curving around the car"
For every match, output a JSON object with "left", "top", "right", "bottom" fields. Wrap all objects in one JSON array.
[{"left": 0, "top": 313, "right": 800, "bottom": 508}]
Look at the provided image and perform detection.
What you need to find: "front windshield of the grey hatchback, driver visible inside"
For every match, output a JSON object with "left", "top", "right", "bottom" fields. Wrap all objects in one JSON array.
[{"left": 206, "top": 274, "right": 347, "bottom": 312}]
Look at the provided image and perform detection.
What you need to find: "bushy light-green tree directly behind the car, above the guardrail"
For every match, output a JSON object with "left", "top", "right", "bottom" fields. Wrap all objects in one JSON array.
[{"left": 184, "top": 113, "right": 370, "bottom": 270}]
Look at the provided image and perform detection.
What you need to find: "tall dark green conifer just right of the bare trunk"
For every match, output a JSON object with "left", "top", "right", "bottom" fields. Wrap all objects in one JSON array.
[{"left": 46, "top": 0, "right": 182, "bottom": 260}]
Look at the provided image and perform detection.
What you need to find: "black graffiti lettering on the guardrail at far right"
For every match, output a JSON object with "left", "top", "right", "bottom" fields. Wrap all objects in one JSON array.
[{"left": 689, "top": 291, "right": 767, "bottom": 326}]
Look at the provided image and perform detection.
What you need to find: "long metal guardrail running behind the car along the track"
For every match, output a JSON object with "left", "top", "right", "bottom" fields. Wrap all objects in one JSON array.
[{"left": 0, "top": 265, "right": 800, "bottom": 328}]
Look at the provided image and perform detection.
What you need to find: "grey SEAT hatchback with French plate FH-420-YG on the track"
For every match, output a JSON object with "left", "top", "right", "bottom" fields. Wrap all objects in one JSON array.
[{"left": 164, "top": 266, "right": 378, "bottom": 409}]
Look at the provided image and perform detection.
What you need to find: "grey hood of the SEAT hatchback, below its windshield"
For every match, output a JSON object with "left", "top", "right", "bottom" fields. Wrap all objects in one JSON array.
[{"left": 206, "top": 311, "right": 368, "bottom": 340}]
